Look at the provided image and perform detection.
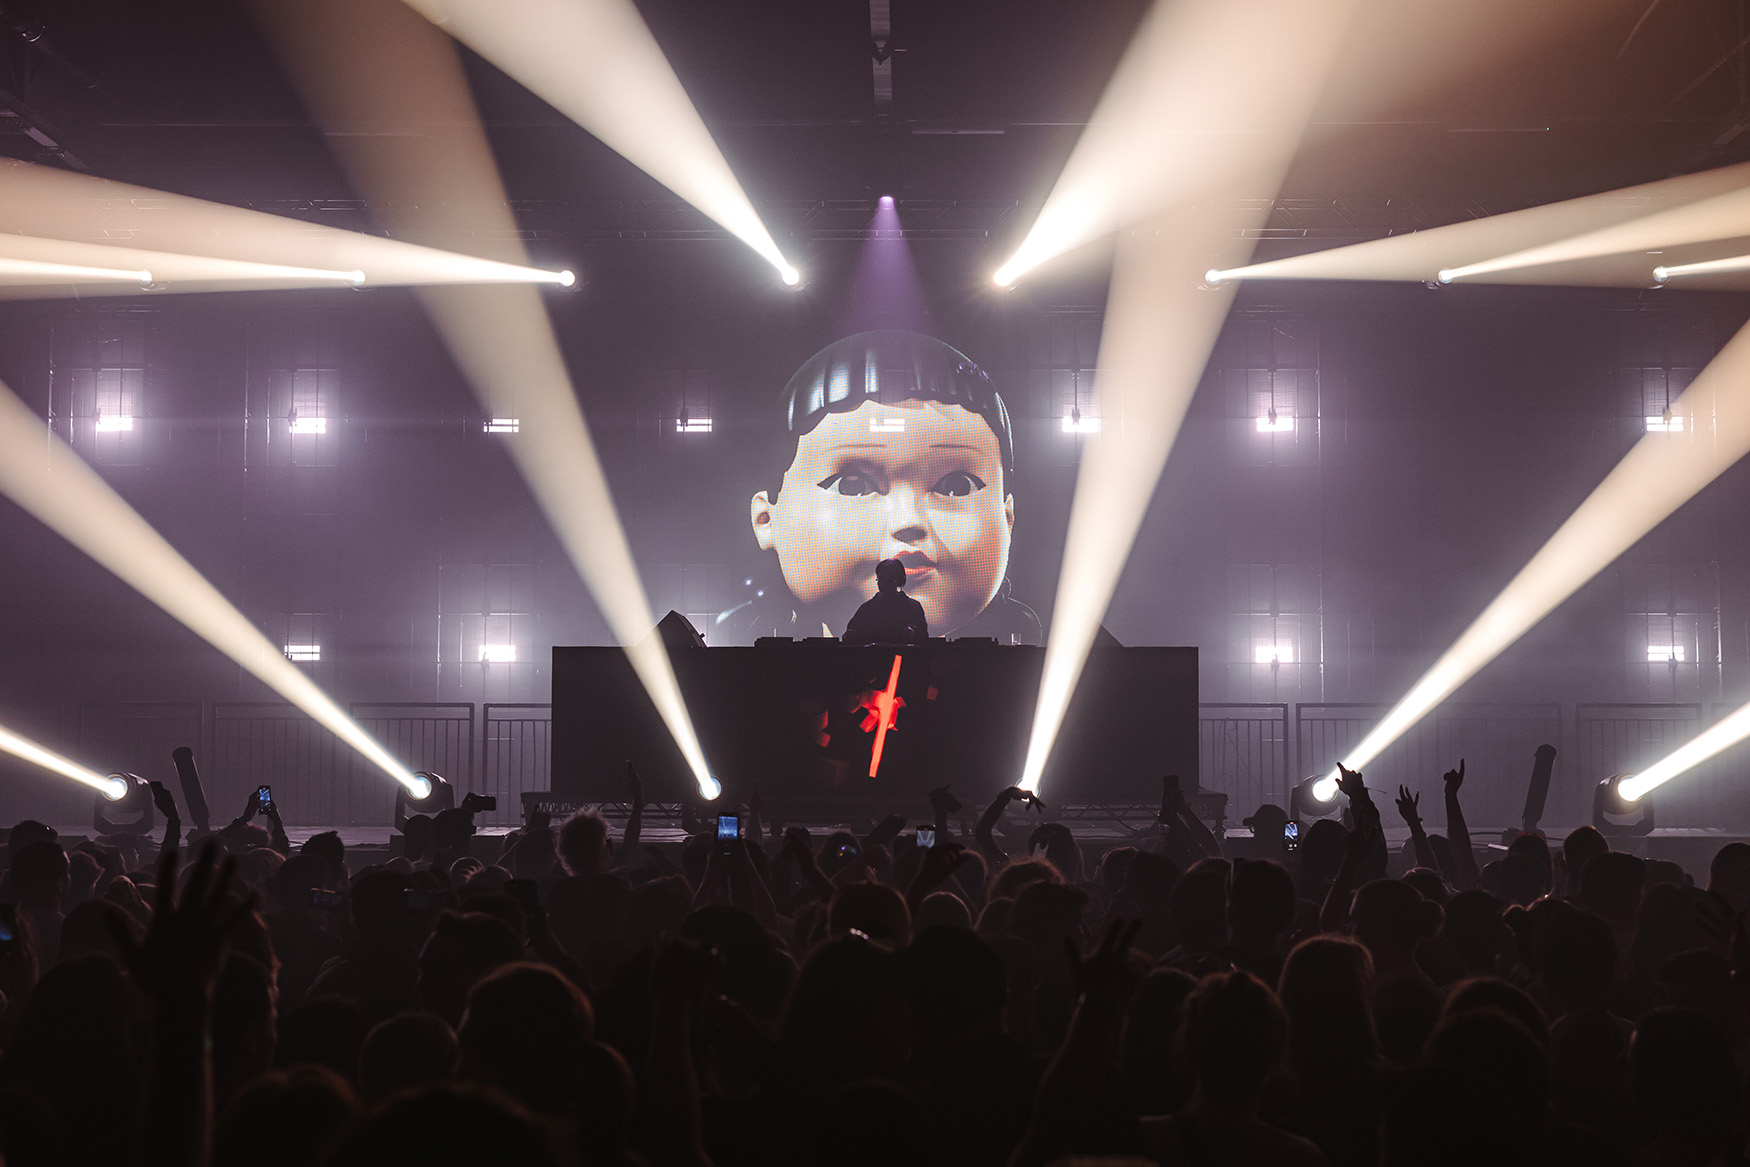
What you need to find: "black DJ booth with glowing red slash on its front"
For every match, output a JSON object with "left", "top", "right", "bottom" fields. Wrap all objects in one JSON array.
[{"left": 551, "top": 640, "right": 1197, "bottom": 819}]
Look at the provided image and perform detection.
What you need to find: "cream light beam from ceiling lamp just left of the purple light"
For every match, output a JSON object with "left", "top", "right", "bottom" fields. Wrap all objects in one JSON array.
[{"left": 406, "top": 0, "right": 801, "bottom": 285}]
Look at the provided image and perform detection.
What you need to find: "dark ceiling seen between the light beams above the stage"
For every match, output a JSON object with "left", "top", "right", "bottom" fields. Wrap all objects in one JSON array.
[{"left": 0, "top": 0, "right": 1750, "bottom": 260}]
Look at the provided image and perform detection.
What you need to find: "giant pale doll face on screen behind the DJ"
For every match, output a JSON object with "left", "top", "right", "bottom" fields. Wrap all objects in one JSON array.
[{"left": 753, "top": 401, "right": 1015, "bottom": 635}]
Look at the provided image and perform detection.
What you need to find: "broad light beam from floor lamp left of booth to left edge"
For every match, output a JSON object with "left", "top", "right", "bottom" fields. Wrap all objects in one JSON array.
[{"left": 0, "top": 385, "right": 425, "bottom": 796}]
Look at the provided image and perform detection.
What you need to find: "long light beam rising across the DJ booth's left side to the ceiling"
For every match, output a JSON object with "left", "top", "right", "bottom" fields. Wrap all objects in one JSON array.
[{"left": 250, "top": 0, "right": 723, "bottom": 800}]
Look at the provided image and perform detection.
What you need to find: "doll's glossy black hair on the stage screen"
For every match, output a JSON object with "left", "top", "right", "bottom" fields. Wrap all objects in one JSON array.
[{"left": 767, "top": 329, "right": 1015, "bottom": 500}]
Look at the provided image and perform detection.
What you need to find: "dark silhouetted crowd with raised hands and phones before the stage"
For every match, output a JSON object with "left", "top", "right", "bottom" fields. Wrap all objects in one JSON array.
[{"left": 0, "top": 770, "right": 1750, "bottom": 1167}]
